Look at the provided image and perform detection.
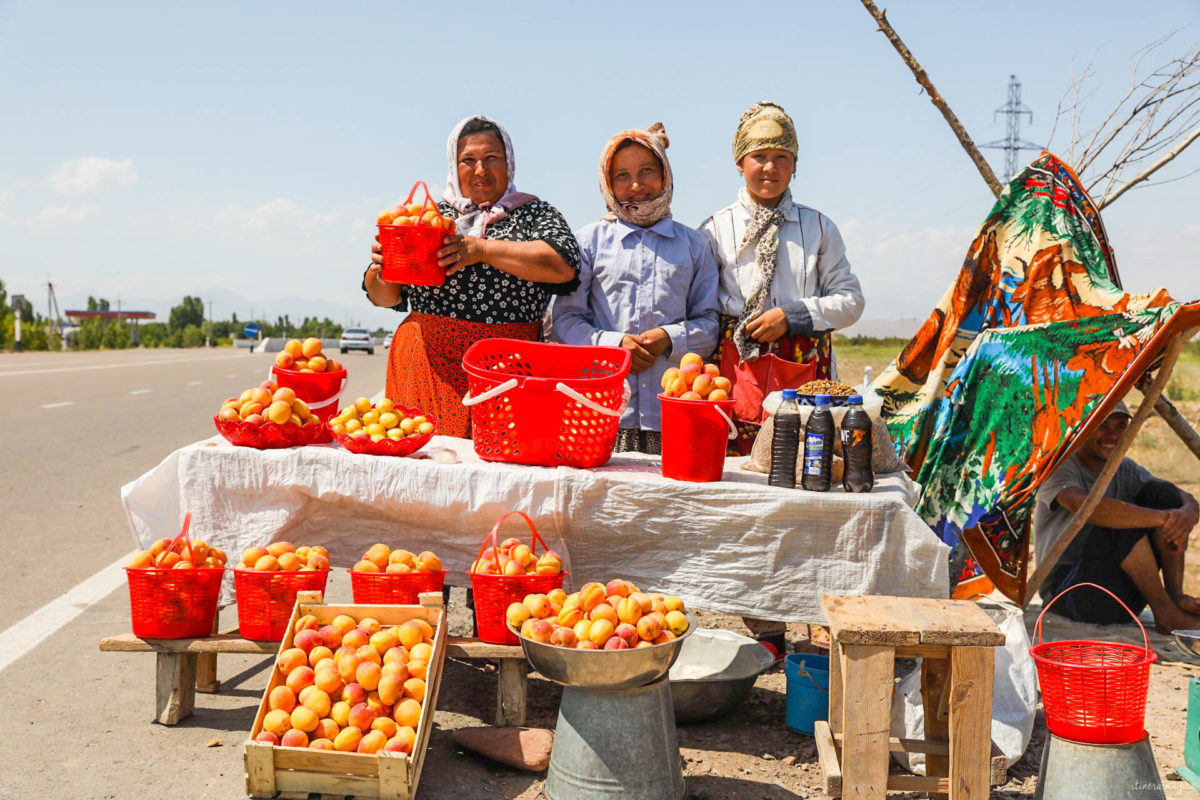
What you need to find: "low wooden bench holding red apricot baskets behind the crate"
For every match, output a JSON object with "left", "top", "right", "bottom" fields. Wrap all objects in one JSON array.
[{"left": 100, "top": 628, "right": 528, "bottom": 727}]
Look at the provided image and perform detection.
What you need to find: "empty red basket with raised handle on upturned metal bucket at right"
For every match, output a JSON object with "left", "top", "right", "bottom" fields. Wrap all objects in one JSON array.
[{"left": 1030, "top": 583, "right": 1158, "bottom": 745}]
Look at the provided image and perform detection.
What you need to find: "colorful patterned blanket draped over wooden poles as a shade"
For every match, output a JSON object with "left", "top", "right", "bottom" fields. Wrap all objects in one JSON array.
[{"left": 875, "top": 154, "right": 1181, "bottom": 603}]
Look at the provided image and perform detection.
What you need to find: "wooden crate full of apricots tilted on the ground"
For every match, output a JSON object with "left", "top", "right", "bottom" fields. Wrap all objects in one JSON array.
[{"left": 245, "top": 593, "right": 446, "bottom": 800}]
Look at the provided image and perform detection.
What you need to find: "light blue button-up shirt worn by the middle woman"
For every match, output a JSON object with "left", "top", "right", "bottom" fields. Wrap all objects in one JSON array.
[{"left": 553, "top": 217, "right": 719, "bottom": 431}]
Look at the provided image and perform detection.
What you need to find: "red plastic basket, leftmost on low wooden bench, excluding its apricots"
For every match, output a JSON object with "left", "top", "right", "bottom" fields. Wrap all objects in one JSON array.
[{"left": 125, "top": 567, "right": 224, "bottom": 639}]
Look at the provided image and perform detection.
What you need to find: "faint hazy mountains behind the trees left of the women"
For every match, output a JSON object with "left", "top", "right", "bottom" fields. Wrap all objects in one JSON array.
[{"left": 59, "top": 287, "right": 401, "bottom": 330}]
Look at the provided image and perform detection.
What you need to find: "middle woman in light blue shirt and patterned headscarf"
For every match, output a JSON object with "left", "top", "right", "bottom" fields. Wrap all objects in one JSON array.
[{"left": 553, "top": 122, "right": 719, "bottom": 455}]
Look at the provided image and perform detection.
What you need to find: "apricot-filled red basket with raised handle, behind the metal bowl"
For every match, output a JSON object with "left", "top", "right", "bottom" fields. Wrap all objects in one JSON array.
[{"left": 468, "top": 511, "right": 569, "bottom": 644}]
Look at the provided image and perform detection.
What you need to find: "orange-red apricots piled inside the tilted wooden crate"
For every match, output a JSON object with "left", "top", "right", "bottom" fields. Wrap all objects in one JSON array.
[{"left": 251, "top": 607, "right": 444, "bottom": 758}]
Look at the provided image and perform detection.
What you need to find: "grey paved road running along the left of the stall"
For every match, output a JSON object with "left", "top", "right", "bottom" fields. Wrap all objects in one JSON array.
[{"left": 0, "top": 349, "right": 386, "bottom": 800}]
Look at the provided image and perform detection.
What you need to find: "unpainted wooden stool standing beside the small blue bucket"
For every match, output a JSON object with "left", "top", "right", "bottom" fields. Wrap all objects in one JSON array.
[{"left": 815, "top": 595, "right": 1004, "bottom": 800}]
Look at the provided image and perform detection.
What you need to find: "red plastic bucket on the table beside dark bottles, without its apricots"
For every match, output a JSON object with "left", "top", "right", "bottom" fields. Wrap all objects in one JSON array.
[{"left": 659, "top": 395, "right": 738, "bottom": 483}]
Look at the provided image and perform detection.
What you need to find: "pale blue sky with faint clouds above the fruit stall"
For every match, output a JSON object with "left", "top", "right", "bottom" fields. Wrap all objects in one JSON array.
[{"left": 0, "top": 0, "right": 1200, "bottom": 326}]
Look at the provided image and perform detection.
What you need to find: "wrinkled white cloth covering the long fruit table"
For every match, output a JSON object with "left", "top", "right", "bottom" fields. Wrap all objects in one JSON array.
[{"left": 121, "top": 437, "right": 948, "bottom": 622}]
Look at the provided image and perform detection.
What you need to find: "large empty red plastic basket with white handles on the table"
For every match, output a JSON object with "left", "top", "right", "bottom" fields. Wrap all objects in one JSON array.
[{"left": 462, "top": 338, "right": 630, "bottom": 468}]
